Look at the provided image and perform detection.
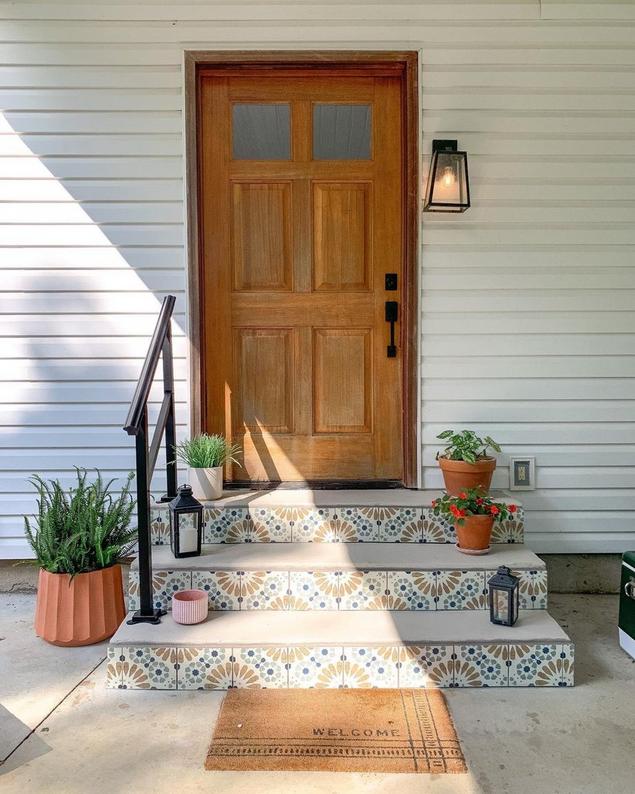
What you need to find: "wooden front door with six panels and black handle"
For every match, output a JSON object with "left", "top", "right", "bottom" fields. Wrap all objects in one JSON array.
[{"left": 198, "top": 67, "right": 404, "bottom": 482}]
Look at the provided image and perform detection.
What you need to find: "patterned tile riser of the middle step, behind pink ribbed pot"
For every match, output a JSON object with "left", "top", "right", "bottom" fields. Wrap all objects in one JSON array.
[{"left": 129, "top": 570, "right": 547, "bottom": 611}]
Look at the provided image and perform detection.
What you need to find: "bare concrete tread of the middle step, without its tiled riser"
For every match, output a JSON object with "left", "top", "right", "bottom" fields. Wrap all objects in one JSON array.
[{"left": 137, "top": 542, "right": 546, "bottom": 571}]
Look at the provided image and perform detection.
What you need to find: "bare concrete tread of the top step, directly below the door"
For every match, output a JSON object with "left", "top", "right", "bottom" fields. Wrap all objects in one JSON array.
[{"left": 156, "top": 488, "right": 522, "bottom": 508}]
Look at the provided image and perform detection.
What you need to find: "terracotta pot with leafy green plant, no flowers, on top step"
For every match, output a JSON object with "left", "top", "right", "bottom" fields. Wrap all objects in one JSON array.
[{"left": 437, "top": 430, "right": 501, "bottom": 496}]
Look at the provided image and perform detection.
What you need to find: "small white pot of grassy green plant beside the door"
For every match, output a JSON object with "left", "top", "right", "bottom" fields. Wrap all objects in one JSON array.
[{"left": 174, "top": 433, "right": 240, "bottom": 501}]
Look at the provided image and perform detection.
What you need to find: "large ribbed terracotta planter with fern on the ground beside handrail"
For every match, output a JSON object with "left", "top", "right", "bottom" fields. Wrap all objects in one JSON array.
[{"left": 24, "top": 469, "right": 137, "bottom": 646}]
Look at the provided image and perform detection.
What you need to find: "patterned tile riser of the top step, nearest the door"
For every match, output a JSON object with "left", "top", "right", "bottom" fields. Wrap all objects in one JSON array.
[{"left": 152, "top": 505, "right": 524, "bottom": 545}]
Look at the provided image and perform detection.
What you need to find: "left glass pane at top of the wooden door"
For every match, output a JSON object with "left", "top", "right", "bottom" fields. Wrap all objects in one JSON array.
[{"left": 232, "top": 103, "right": 291, "bottom": 160}]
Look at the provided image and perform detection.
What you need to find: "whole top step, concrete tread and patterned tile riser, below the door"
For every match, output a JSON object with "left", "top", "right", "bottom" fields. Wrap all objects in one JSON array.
[{"left": 152, "top": 488, "right": 524, "bottom": 545}]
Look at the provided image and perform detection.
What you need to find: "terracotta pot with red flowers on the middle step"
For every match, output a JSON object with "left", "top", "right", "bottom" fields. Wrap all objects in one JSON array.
[{"left": 432, "top": 488, "right": 517, "bottom": 554}]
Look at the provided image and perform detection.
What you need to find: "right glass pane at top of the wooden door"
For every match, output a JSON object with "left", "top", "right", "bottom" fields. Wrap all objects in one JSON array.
[{"left": 313, "top": 105, "right": 372, "bottom": 160}]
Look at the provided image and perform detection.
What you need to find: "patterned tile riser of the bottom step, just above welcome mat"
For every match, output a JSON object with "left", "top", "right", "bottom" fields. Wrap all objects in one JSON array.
[{"left": 106, "top": 643, "right": 574, "bottom": 690}]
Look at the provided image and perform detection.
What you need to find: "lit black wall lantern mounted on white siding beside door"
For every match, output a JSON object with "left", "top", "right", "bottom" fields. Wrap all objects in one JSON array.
[{"left": 423, "top": 140, "right": 470, "bottom": 212}]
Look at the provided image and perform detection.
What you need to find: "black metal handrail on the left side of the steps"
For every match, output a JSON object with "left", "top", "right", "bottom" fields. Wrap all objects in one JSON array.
[{"left": 123, "top": 295, "right": 176, "bottom": 624}]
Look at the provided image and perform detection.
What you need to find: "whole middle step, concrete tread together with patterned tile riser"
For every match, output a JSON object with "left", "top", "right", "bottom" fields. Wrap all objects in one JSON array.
[{"left": 129, "top": 543, "right": 547, "bottom": 611}]
